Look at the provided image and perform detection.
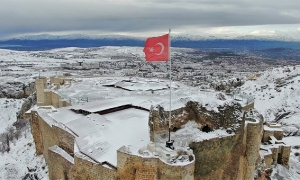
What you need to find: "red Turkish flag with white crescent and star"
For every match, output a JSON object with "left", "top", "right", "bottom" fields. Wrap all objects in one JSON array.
[{"left": 143, "top": 34, "right": 170, "bottom": 62}]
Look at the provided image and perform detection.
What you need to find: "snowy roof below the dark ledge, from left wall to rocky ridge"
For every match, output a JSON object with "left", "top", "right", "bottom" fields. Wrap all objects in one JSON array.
[{"left": 39, "top": 108, "right": 150, "bottom": 166}]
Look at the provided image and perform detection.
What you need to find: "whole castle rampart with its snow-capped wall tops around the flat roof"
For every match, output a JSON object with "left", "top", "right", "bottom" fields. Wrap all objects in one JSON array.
[{"left": 30, "top": 77, "right": 290, "bottom": 180}]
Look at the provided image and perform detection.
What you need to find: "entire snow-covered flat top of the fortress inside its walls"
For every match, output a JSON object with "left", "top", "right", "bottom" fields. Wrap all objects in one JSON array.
[{"left": 38, "top": 77, "right": 253, "bottom": 166}]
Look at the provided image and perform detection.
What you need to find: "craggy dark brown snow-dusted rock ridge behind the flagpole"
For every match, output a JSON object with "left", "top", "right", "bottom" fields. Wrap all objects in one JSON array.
[{"left": 149, "top": 101, "right": 242, "bottom": 141}]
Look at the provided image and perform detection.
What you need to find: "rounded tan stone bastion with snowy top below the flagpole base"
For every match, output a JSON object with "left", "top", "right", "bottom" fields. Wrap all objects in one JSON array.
[{"left": 117, "top": 143, "right": 195, "bottom": 180}]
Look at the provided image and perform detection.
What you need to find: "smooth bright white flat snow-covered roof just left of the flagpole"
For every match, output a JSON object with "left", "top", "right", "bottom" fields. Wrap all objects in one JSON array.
[{"left": 76, "top": 108, "right": 150, "bottom": 166}]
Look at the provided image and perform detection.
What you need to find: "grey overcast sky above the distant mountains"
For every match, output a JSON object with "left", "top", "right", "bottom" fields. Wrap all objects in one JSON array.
[{"left": 0, "top": 0, "right": 300, "bottom": 39}]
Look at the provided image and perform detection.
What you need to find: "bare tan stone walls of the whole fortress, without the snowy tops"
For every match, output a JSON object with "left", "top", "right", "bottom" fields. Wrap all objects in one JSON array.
[{"left": 30, "top": 77, "right": 290, "bottom": 180}]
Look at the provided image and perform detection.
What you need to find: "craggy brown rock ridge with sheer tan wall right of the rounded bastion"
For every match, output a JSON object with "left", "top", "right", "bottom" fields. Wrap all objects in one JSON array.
[{"left": 149, "top": 101, "right": 263, "bottom": 179}]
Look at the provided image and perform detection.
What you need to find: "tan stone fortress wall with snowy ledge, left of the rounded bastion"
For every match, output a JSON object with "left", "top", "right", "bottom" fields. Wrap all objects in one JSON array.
[{"left": 30, "top": 105, "right": 116, "bottom": 180}]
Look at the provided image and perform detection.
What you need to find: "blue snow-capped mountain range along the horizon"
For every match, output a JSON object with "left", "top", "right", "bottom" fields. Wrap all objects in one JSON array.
[{"left": 0, "top": 34, "right": 300, "bottom": 59}]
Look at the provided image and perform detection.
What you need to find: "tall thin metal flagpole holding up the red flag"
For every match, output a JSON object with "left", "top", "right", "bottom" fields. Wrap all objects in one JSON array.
[{"left": 166, "top": 29, "right": 174, "bottom": 149}]
